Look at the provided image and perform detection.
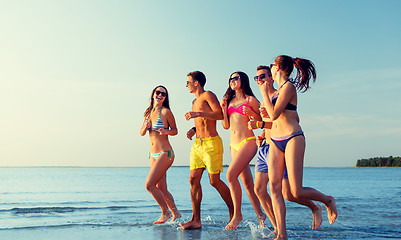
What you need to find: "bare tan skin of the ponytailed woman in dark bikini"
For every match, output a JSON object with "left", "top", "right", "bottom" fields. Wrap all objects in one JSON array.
[{"left": 259, "top": 63, "right": 337, "bottom": 239}]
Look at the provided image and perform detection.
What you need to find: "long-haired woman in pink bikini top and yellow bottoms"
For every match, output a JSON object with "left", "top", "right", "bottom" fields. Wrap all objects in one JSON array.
[{"left": 220, "top": 72, "right": 266, "bottom": 229}]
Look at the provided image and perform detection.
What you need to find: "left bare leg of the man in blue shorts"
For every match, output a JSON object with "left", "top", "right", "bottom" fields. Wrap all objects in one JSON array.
[{"left": 255, "top": 172, "right": 277, "bottom": 233}]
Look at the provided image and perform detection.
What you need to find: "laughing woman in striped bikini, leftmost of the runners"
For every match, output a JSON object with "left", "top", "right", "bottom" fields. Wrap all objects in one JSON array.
[{"left": 140, "top": 86, "right": 181, "bottom": 224}]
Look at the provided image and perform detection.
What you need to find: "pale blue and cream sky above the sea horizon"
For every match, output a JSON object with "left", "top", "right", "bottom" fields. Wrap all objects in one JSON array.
[{"left": 0, "top": 0, "right": 401, "bottom": 167}]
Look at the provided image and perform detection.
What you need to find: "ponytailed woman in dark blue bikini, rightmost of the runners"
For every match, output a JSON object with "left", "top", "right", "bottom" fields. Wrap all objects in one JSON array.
[{"left": 259, "top": 55, "right": 337, "bottom": 239}]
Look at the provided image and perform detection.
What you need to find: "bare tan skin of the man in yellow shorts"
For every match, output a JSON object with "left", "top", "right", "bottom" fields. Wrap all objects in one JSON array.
[{"left": 180, "top": 76, "right": 234, "bottom": 230}]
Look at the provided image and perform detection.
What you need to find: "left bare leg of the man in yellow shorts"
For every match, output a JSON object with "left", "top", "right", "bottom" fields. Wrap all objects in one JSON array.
[{"left": 180, "top": 168, "right": 205, "bottom": 230}]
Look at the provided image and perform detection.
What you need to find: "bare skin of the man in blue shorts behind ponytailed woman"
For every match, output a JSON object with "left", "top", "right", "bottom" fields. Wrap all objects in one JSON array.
[{"left": 248, "top": 69, "right": 322, "bottom": 234}]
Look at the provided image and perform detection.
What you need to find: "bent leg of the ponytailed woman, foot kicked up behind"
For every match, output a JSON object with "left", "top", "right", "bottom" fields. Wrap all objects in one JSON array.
[{"left": 285, "top": 136, "right": 337, "bottom": 224}]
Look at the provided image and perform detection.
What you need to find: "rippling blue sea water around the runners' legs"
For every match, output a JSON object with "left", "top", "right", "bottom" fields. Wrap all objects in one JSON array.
[{"left": 0, "top": 167, "right": 401, "bottom": 240}]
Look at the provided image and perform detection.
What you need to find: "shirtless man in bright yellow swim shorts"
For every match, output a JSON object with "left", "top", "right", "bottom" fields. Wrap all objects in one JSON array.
[{"left": 180, "top": 71, "right": 234, "bottom": 230}]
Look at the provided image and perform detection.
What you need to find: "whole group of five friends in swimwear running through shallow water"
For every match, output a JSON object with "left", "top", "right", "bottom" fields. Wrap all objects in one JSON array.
[{"left": 140, "top": 55, "right": 337, "bottom": 239}]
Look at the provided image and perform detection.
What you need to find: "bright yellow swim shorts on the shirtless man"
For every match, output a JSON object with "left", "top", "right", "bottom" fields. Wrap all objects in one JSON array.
[{"left": 190, "top": 135, "right": 223, "bottom": 174}]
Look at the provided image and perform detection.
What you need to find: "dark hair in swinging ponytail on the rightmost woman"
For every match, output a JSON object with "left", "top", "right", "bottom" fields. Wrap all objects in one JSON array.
[{"left": 274, "top": 55, "right": 316, "bottom": 92}]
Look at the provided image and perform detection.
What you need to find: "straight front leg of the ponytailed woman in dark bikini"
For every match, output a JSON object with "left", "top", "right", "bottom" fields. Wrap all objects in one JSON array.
[{"left": 268, "top": 144, "right": 287, "bottom": 239}]
